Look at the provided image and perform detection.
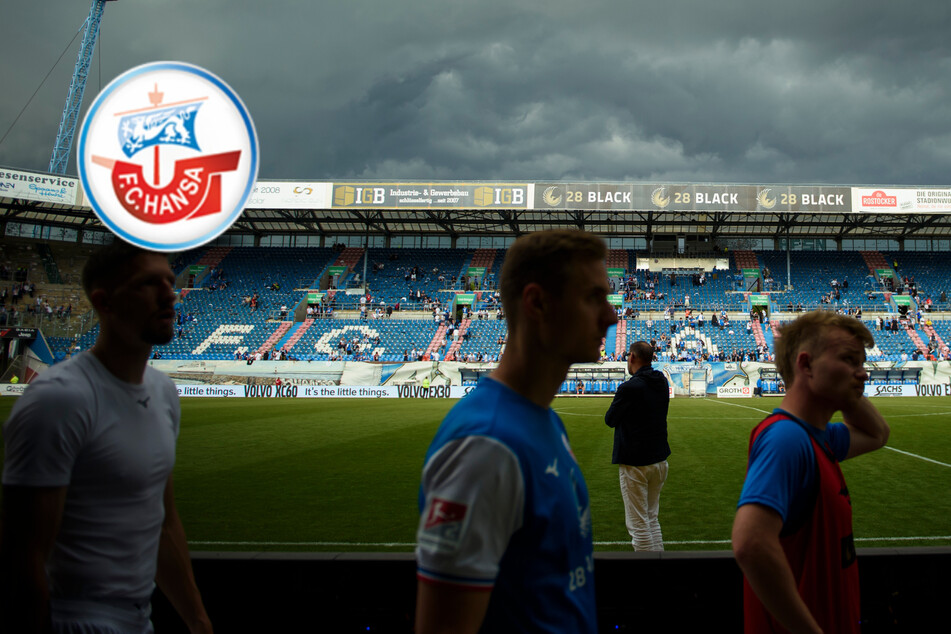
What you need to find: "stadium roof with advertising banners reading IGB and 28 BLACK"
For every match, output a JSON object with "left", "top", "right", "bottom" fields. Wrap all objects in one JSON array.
[{"left": 0, "top": 169, "right": 951, "bottom": 240}]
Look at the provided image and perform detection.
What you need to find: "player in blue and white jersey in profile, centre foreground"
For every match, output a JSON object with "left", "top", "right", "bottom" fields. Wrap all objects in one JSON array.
[{"left": 416, "top": 231, "right": 617, "bottom": 634}]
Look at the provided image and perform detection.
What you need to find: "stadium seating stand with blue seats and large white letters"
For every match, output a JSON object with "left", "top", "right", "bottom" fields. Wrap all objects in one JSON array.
[{"left": 0, "top": 239, "right": 951, "bottom": 368}]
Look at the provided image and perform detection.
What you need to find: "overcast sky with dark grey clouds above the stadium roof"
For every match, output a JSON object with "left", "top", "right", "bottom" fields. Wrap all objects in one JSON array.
[{"left": 0, "top": 0, "right": 951, "bottom": 185}]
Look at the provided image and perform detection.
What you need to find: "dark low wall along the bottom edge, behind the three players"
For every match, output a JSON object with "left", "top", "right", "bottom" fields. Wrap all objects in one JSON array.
[{"left": 153, "top": 548, "right": 951, "bottom": 634}]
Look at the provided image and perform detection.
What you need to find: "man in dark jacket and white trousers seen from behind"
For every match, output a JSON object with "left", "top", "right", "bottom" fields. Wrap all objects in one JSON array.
[{"left": 604, "top": 341, "right": 670, "bottom": 550}]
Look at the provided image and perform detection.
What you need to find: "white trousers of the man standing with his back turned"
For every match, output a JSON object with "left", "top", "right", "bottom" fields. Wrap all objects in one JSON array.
[{"left": 619, "top": 460, "right": 667, "bottom": 550}]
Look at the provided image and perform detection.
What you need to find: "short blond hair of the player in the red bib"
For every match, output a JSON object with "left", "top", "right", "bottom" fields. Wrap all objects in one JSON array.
[{"left": 776, "top": 310, "right": 875, "bottom": 386}]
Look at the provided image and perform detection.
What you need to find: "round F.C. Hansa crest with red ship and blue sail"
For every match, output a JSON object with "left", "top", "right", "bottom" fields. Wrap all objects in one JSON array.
[{"left": 77, "top": 62, "right": 258, "bottom": 251}]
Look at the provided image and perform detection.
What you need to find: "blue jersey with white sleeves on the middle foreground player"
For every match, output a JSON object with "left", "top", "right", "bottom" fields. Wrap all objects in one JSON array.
[{"left": 416, "top": 379, "right": 597, "bottom": 633}]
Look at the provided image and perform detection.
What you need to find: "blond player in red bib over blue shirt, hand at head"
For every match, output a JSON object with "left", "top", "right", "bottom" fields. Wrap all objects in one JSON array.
[{"left": 733, "top": 311, "right": 889, "bottom": 633}]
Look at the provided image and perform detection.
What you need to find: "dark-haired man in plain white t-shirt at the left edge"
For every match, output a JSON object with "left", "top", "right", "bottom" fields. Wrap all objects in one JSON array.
[{"left": 0, "top": 240, "right": 212, "bottom": 634}]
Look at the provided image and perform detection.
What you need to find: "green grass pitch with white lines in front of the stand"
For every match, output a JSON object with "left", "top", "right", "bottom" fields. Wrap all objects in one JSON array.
[{"left": 0, "top": 397, "right": 951, "bottom": 552}]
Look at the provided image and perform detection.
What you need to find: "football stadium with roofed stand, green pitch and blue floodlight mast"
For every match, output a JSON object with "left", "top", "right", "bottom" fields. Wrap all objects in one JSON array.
[{"left": 0, "top": 1, "right": 951, "bottom": 632}]
